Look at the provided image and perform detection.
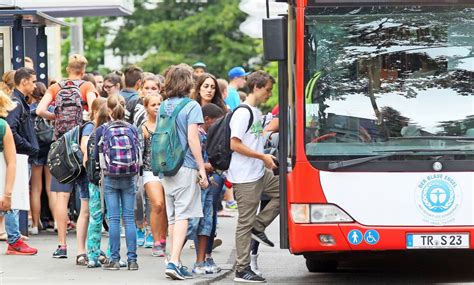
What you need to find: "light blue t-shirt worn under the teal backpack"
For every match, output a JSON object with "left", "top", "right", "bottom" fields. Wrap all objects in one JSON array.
[{"left": 162, "top": 97, "right": 204, "bottom": 169}]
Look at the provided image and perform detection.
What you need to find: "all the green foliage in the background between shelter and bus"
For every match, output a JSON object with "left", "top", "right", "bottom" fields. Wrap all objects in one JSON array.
[{"left": 62, "top": 0, "right": 278, "bottom": 111}]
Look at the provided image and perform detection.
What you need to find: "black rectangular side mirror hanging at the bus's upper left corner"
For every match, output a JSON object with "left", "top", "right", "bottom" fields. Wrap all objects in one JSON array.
[{"left": 262, "top": 17, "right": 288, "bottom": 61}]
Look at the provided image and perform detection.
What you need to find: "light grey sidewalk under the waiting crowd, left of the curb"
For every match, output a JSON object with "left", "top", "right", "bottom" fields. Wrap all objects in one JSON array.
[{"left": 0, "top": 213, "right": 237, "bottom": 285}]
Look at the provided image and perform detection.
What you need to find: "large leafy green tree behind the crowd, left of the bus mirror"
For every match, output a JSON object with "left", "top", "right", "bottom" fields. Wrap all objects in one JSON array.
[{"left": 110, "top": 0, "right": 259, "bottom": 77}]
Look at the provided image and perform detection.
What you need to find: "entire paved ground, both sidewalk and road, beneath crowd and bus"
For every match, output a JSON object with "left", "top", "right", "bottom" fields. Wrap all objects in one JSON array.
[{"left": 0, "top": 214, "right": 474, "bottom": 285}]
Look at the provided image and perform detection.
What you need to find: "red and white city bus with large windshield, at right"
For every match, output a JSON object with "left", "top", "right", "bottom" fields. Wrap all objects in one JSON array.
[{"left": 263, "top": 0, "right": 474, "bottom": 272}]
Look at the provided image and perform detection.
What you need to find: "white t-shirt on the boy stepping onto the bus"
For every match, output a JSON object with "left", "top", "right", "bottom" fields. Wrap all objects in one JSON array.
[{"left": 227, "top": 105, "right": 265, "bottom": 183}]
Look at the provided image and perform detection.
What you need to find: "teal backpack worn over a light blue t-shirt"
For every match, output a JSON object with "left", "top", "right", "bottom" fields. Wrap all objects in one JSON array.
[{"left": 151, "top": 98, "right": 191, "bottom": 176}]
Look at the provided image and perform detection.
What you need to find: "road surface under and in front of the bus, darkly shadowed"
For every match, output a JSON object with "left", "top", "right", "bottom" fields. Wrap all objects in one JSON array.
[{"left": 216, "top": 217, "right": 474, "bottom": 284}]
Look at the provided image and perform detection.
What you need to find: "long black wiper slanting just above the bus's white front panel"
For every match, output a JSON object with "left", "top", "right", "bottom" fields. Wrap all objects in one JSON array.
[{"left": 328, "top": 149, "right": 465, "bottom": 170}]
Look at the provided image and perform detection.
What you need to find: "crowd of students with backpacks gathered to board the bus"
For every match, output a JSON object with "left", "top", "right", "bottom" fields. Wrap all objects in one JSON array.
[{"left": 0, "top": 54, "right": 279, "bottom": 282}]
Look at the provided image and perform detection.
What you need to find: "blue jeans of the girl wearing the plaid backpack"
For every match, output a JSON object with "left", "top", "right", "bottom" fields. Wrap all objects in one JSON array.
[{"left": 104, "top": 176, "right": 137, "bottom": 262}]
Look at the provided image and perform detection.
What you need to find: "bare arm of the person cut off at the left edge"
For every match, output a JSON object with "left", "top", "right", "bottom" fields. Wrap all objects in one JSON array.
[{"left": 0, "top": 126, "right": 16, "bottom": 211}]
